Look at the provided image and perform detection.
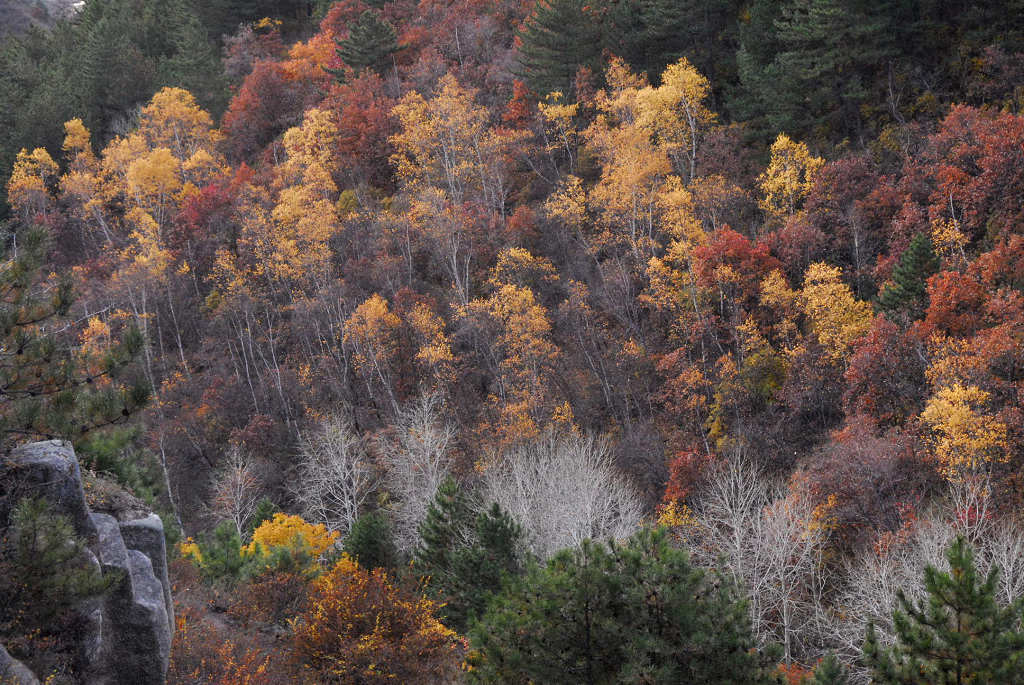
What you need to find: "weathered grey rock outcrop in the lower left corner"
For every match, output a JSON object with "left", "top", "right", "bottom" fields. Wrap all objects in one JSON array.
[{"left": 0, "top": 440, "right": 174, "bottom": 685}]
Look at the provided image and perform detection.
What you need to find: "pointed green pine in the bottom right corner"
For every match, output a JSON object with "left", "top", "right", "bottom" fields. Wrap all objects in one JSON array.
[{"left": 864, "top": 537, "right": 1024, "bottom": 685}]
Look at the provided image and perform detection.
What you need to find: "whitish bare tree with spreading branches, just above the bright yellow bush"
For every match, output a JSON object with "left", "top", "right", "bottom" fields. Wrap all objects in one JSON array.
[{"left": 293, "top": 416, "right": 379, "bottom": 534}]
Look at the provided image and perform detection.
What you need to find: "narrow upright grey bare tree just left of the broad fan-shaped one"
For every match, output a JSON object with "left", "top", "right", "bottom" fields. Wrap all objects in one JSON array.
[{"left": 378, "top": 393, "right": 456, "bottom": 552}]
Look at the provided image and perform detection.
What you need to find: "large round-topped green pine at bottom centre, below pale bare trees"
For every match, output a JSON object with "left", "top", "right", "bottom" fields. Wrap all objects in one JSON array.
[{"left": 469, "top": 530, "right": 775, "bottom": 685}]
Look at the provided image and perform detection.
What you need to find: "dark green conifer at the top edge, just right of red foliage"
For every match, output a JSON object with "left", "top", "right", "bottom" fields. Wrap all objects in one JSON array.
[{"left": 516, "top": 0, "right": 602, "bottom": 97}]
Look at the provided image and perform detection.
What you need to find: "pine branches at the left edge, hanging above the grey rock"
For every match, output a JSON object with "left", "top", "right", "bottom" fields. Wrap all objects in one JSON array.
[{"left": 0, "top": 228, "right": 148, "bottom": 446}]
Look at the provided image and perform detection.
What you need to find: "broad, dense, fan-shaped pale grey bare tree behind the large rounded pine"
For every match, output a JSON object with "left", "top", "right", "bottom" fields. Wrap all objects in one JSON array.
[{"left": 482, "top": 432, "right": 643, "bottom": 558}]
